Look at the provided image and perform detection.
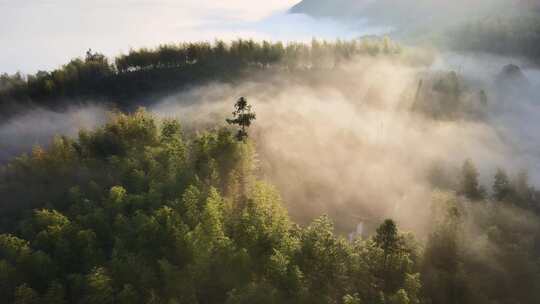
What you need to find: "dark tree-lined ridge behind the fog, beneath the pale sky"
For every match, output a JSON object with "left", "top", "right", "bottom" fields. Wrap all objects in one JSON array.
[{"left": 0, "top": 38, "right": 401, "bottom": 116}]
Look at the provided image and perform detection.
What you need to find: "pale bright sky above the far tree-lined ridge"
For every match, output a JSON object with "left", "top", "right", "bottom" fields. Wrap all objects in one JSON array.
[{"left": 0, "top": 0, "right": 381, "bottom": 74}]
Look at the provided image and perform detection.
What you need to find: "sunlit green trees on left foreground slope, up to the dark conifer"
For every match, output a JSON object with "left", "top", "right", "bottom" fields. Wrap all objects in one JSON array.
[{"left": 0, "top": 110, "right": 421, "bottom": 303}]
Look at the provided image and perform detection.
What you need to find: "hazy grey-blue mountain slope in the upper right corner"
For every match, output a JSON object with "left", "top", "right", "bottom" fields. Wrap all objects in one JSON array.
[{"left": 291, "top": 0, "right": 540, "bottom": 63}]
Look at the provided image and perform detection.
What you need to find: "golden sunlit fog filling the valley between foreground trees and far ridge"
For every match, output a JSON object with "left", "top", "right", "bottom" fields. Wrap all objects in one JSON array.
[{"left": 0, "top": 53, "right": 540, "bottom": 234}]
